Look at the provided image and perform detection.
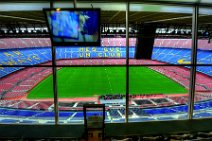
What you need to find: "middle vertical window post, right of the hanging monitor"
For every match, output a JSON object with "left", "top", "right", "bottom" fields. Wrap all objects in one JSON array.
[{"left": 125, "top": 1, "right": 130, "bottom": 122}]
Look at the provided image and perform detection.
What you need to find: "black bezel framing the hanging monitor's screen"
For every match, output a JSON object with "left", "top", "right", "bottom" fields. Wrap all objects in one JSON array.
[{"left": 43, "top": 8, "right": 101, "bottom": 47}]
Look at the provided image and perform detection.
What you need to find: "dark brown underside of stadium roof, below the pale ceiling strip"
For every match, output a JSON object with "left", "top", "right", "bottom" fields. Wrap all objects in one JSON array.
[{"left": 0, "top": 11, "right": 212, "bottom": 24}]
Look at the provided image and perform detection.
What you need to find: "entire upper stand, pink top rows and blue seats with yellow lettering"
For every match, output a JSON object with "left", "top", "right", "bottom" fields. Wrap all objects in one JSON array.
[{"left": 0, "top": 38, "right": 212, "bottom": 78}]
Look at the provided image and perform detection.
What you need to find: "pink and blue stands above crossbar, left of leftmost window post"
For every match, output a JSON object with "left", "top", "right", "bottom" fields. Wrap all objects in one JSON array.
[{"left": 0, "top": 38, "right": 52, "bottom": 66}]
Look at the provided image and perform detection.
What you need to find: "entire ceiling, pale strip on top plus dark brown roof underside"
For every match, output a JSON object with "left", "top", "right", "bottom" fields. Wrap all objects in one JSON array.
[{"left": 0, "top": 0, "right": 212, "bottom": 25}]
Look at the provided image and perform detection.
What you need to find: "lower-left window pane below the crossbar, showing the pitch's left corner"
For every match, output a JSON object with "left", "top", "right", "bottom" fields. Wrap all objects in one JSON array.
[{"left": 0, "top": 67, "right": 54, "bottom": 124}]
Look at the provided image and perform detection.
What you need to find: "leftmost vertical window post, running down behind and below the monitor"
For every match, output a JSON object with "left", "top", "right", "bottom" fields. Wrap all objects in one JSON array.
[{"left": 50, "top": 1, "right": 59, "bottom": 125}]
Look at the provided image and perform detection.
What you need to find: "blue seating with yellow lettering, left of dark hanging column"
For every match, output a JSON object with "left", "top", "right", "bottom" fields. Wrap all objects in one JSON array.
[{"left": 0, "top": 47, "right": 135, "bottom": 78}]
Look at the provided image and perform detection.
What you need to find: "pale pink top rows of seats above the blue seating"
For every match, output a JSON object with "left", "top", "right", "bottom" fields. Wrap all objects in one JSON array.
[{"left": 0, "top": 38, "right": 212, "bottom": 50}]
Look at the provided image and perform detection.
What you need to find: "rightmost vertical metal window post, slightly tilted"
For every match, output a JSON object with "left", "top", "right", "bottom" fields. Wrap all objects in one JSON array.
[{"left": 188, "top": 5, "right": 199, "bottom": 119}]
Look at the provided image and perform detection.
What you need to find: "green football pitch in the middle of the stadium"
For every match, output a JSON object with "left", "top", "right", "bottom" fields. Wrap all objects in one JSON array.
[{"left": 28, "top": 66, "right": 187, "bottom": 99}]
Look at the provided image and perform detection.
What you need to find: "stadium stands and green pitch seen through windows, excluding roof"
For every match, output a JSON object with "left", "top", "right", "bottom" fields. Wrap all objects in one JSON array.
[{"left": 1, "top": 38, "right": 212, "bottom": 123}]
